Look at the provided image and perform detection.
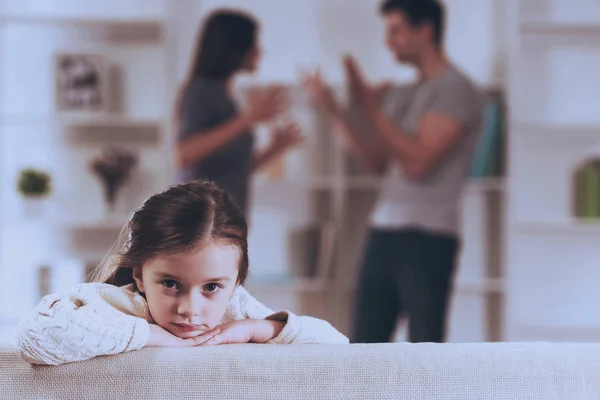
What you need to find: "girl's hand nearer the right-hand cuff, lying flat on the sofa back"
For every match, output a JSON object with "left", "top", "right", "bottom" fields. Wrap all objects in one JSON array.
[{"left": 202, "top": 319, "right": 284, "bottom": 346}]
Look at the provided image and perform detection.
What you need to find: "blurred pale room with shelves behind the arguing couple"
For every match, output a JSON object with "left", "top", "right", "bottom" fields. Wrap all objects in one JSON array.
[{"left": 0, "top": 0, "right": 600, "bottom": 345}]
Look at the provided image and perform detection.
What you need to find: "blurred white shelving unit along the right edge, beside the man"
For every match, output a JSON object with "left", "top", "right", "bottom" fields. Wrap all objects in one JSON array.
[{"left": 504, "top": 0, "right": 600, "bottom": 341}]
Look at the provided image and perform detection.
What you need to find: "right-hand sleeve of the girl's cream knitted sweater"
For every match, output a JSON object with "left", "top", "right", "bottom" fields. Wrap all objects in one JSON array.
[{"left": 233, "top": 288, "right": 349, "bottom": 344}]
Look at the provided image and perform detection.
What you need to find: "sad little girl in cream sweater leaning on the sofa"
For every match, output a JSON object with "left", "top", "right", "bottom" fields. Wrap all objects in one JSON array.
[{"left": 15, "top": 181, "right": 348, "bottom": 365}]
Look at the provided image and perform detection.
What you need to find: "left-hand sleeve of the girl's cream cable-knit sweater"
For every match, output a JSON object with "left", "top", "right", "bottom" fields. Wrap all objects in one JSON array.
[{"left": 15, "top": 284, "right": 150, "bottom": 365}]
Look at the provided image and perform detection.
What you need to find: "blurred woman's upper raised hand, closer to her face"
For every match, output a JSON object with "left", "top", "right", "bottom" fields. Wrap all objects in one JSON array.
[{"left": 245, "top": 86, "right": 289, "bottom": 124}]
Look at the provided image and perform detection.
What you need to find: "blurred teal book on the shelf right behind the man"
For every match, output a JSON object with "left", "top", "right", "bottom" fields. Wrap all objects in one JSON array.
[{"left": 469, "top": 96, "right": 505, "bottom": 178}]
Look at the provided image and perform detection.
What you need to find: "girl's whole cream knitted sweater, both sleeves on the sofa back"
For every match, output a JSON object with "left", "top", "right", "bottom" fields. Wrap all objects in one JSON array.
[{"left": 15, "top": 283, "right": 348, "bottom": 365}]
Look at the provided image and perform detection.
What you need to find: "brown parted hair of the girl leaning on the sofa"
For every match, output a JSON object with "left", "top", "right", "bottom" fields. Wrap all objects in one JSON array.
[{"left": 92, "top": 181, "right": 249, "bottom": 286}]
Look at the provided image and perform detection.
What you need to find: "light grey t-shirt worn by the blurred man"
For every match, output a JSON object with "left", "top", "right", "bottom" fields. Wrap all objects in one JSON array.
[{"left": 371, "top": 66, "right": 484, "bottom": 234}]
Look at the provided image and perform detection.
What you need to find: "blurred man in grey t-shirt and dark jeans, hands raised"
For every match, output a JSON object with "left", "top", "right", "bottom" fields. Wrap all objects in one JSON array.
[{"left": 304, "top": 0, "right": 483, "bottom": 343}]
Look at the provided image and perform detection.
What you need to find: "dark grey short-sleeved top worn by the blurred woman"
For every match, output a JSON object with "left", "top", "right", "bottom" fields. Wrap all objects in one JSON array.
[{"left": 178, "top": 79, "right": 254, "bottom": 215}]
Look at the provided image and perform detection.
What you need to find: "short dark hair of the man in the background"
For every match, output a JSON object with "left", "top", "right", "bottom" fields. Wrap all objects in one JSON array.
[{"left": 380, "top": 0, "right": 445, "bottom": 47}]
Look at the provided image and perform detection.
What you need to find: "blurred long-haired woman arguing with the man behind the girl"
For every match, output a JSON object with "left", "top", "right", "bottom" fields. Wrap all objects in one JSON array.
[{"left": 175, "top": 10, "right": 302, "bottom": 215}]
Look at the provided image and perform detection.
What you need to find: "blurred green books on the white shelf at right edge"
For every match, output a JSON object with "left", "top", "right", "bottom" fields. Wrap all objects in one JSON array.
[{"left": 572, "top": 160, "right": 600, "bottom": 221}]
